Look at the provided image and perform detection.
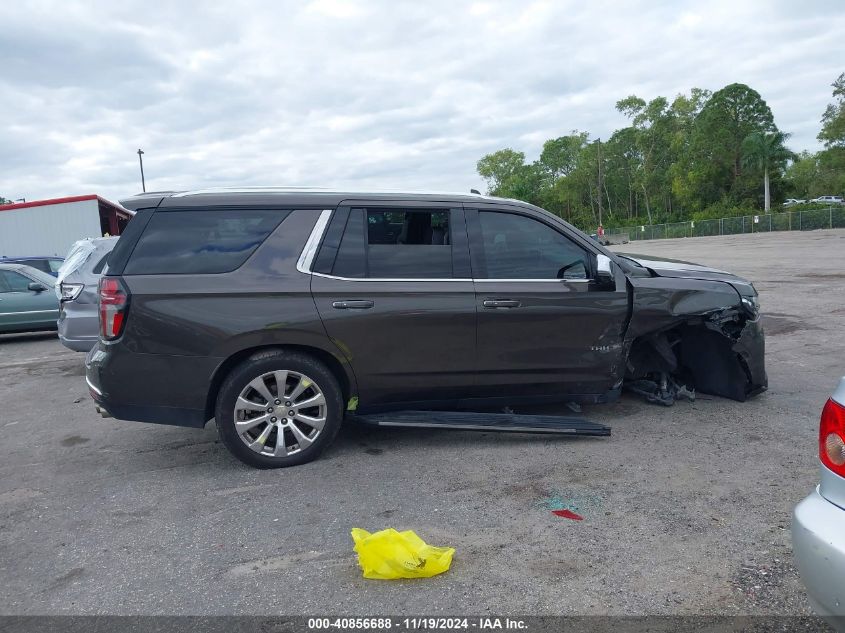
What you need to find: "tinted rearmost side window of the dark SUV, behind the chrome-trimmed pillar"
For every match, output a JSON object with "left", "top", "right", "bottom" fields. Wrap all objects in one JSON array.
[{"left": 123, "top": 209, "right": 290, "bottom": 275}]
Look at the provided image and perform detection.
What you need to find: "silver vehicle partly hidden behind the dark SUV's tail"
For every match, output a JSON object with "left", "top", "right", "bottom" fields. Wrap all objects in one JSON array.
[{"left": 56, "top": 237, "right": 118, "bottom": 352}]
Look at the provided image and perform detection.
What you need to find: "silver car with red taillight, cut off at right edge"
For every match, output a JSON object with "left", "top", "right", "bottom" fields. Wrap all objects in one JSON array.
[{"left": 792, "top": 378, "right": 845, "bottom": 631}]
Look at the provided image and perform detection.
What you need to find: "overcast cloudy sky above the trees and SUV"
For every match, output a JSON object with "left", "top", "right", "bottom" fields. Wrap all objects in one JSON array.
[{"left": 0, "top": 0, "right": 845, "bottom": 200}]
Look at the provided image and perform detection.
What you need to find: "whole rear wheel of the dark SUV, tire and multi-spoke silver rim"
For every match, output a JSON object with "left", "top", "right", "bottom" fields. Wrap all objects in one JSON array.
[{"left": 214, "top": 350, "right": 343, "bottom": 468}]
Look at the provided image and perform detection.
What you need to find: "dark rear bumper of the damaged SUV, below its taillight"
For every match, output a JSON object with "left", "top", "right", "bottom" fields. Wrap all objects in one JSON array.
[{"left": 85, "top": 341, "right": 220, "bottom": 428}]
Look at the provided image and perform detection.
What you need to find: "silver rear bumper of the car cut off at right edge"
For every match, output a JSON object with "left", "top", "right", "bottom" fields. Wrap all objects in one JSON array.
[{"left": 792, "top": 490, "right": 845, "bottom": 631}]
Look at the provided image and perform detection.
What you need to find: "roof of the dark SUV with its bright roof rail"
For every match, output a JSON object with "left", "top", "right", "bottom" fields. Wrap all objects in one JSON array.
[{"left": 120, "top": 187, "right": 526, "bottom": 210}]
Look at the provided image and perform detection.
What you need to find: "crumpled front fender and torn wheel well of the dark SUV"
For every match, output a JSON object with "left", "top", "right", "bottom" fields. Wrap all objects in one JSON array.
[{"left": 625, "top": 277, "right": 768, "bottom": 404}]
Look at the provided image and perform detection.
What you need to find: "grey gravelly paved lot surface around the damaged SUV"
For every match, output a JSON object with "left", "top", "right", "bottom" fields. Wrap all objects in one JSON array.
[{"left": 0, "top": 230, "right": 845, "bottom": 615}]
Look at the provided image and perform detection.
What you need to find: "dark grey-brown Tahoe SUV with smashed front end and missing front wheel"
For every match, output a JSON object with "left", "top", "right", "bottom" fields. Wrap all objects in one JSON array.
[{"left": 86, "top": 188, "right": 767, "bottom": 467}]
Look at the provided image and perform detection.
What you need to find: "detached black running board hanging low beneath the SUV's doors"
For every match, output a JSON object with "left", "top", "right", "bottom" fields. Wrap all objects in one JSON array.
[{"left": 350, "top": 411, "right": 610, "bottom": 435}]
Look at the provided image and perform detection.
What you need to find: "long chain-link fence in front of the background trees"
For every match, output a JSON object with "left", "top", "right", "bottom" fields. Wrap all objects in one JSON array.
[{"left": 605, "top": 205, "right": 845, "bottom": 242}]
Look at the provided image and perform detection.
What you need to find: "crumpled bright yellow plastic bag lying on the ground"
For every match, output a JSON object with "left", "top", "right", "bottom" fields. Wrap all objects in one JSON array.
[{"left": 352, "top": 528, "right": 455, "bottom": 580}]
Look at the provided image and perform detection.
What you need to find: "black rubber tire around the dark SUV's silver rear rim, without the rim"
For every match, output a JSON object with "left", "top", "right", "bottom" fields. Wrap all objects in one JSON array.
[{"left": 214, "top": 350, "right": 343, "bottom": 468}]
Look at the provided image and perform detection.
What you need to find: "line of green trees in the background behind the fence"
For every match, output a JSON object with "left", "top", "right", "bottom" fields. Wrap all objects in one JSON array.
[{"left": 476, "top": 73, "right": 845, "bottom": 229}]
